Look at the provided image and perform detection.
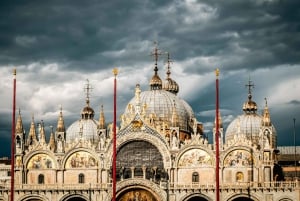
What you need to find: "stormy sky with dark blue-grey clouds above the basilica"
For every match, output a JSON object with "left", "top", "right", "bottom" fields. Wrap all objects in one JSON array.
[{"left": 0, "top": 0, "right": 300, "bottom": 157}]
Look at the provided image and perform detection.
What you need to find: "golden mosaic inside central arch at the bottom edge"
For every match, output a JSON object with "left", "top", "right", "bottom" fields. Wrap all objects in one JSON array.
[{"left": 118, "top": 190, "right": 156, "bottom": 201}]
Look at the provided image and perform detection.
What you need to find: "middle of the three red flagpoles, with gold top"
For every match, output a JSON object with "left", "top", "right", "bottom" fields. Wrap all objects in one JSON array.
[{"left": 112, "top": 68, "right": 118, "bottom": 201}]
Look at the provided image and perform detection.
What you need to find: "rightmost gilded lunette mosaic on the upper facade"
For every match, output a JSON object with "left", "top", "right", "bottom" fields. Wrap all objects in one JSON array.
[{"left": 224, "top": 150, "right": 253, "bottom": 167}]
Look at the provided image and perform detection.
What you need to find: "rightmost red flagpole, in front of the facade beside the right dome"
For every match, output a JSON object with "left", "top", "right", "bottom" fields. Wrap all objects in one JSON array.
[{"left": 215, "top": 69, "right": 220, "bottom": 201}]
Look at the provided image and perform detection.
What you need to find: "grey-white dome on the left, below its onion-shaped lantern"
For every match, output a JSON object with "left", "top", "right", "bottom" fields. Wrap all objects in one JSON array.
[{"left": 66, "top": 119, "right": 98, "bottom": 142}]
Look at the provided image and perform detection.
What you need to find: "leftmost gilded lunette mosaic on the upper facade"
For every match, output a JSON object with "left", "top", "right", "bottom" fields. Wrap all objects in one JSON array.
[{"left": 27, "top": 154, "right": 54, "bottom": 169}]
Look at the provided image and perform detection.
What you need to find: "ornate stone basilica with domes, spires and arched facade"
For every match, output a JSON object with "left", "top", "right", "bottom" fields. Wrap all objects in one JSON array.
[{"left": 0, "top": 48, "right": 300, "bottom": 201}]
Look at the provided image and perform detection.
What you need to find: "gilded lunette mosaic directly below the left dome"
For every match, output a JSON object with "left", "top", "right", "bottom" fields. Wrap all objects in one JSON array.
[{"left": 66, "top": 151, "right": 97, "bottom": 168}]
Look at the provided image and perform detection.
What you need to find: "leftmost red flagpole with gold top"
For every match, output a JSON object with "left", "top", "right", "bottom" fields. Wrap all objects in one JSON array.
[{"left": 10, "top": 69, "right": 17, "bottom": 201}]
